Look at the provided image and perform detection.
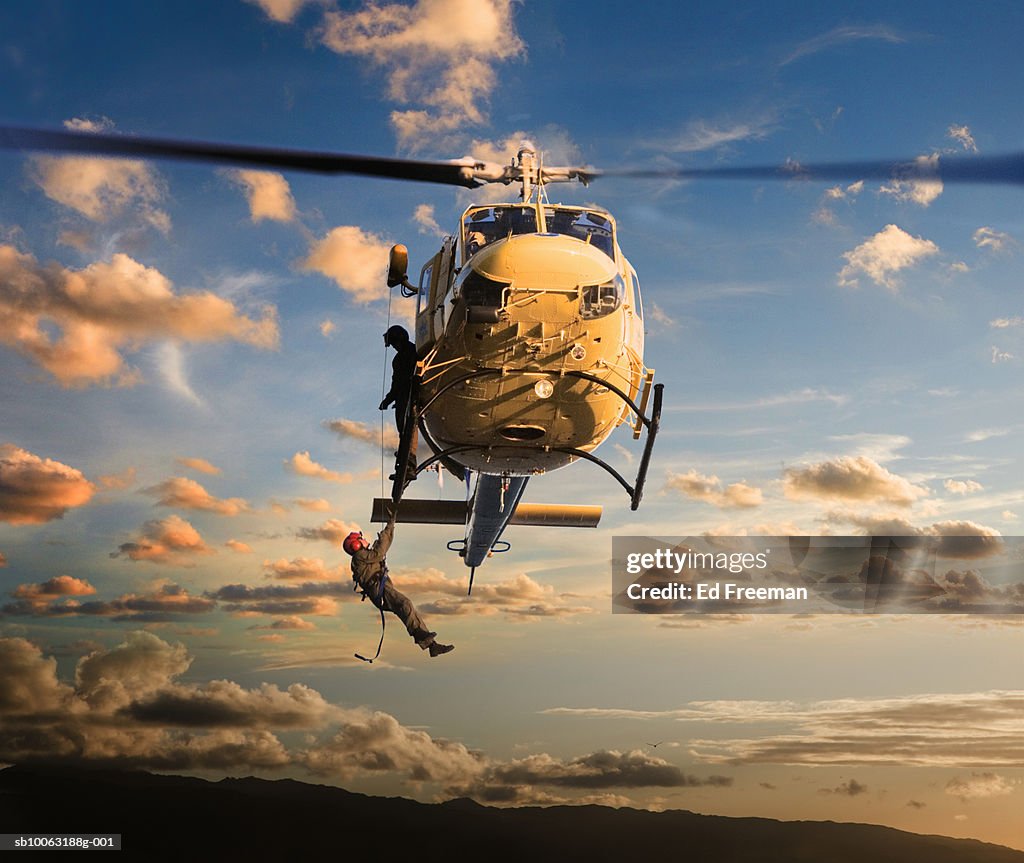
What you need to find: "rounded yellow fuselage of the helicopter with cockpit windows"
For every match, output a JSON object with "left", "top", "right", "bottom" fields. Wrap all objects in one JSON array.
[{"left": 416, "top": 204, "right": 644, "bottom": 476}]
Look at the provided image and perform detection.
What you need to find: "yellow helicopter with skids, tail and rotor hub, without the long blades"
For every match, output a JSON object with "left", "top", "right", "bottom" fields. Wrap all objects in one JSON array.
[{"left": 373, "top": 144, "right": 663, "bottom": 589}]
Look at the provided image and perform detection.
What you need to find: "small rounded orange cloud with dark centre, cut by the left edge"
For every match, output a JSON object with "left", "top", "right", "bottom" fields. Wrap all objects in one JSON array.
[{"left": 0, "top": 443, "right": 96, "bottom": 524}]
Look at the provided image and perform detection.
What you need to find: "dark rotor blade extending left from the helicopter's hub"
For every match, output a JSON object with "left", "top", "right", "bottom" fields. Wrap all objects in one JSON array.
[{"left": 0, "top": 126, "right": 479, "bottom": 188}]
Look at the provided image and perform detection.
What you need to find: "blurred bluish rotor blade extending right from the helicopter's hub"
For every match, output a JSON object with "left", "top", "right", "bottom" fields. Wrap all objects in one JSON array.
[{"left": 587, "top": 153, "right": 1024, "bottom": 185}]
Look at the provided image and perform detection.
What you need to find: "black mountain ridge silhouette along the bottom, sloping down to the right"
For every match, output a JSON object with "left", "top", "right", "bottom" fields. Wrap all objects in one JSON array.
[{"left": 0, "top": 765, "right": 1024, "bottom": 863}]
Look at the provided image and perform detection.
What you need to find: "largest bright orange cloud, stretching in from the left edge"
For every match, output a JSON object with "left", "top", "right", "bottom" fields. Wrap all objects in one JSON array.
[{"left": 0, "top": 245, "right": 278, "bottom": 387}]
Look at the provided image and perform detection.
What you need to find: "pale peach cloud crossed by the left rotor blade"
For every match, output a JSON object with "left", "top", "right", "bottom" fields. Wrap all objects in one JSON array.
[{"left": 30, "top": 119, "right": 171, "bottom": 233}]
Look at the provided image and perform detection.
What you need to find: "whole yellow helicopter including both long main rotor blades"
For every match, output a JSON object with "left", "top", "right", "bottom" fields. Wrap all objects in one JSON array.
[{"left": 0, "top": 126, "right": 1011, "bottom": 587}]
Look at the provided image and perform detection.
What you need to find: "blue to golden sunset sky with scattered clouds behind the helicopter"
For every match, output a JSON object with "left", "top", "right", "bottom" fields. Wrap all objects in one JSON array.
[{"left": 0, "top": 0, "right": 1024, "bottom": 849}]
